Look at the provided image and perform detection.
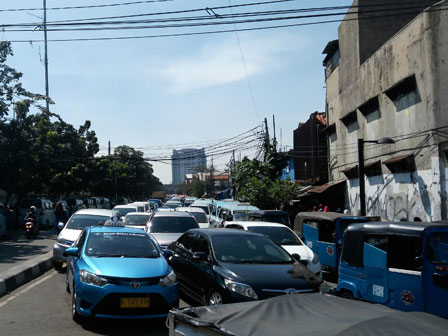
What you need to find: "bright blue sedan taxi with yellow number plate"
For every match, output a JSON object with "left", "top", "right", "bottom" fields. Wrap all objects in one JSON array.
[{"left": 64, "top": 226, "right": 179, "bottom": 322}]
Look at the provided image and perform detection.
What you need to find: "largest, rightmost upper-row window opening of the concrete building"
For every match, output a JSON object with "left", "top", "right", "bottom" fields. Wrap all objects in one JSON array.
[{"left": 384, "top": 75, "right": 422, "bottom": 112}]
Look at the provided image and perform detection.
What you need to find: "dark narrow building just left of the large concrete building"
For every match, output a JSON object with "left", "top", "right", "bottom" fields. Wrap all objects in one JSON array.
[{"left": 291, "top": 111, "right": 328, "bottom": 184}]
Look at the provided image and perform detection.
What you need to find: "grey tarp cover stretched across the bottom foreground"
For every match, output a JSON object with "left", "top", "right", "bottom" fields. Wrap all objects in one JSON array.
[{"left": 170, "top": 293, "right": 448, "bottom": 336}]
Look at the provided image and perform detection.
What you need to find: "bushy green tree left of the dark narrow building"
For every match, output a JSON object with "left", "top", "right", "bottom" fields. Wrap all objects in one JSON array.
[{"left": 235, "top": 155, "right": 299, "bottom": 209}]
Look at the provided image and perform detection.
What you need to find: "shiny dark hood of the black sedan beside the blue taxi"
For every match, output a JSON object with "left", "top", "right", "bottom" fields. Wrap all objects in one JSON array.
[{"left": 217, "top": 263, "right": 321, "bottom": 290}]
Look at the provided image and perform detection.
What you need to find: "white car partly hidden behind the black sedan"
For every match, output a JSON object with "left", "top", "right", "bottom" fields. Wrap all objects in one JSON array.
[{"left": 224, "top": 222, "right": 322, "bottom": 279}]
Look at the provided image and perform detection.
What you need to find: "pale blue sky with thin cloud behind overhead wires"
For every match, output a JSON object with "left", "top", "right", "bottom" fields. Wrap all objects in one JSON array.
[{"left": 0, "top": 0, "right": 352, "bottom": 183}]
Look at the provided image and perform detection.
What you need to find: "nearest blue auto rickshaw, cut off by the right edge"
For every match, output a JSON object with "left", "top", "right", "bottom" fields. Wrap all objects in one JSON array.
[{"left": 337, "top": 222, "right": 448, "bottom": 318}]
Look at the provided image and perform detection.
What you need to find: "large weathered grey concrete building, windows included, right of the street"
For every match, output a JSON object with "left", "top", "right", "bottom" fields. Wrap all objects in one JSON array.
[{"left": 324, "top": 0, "right": 448, "bottom": 221}]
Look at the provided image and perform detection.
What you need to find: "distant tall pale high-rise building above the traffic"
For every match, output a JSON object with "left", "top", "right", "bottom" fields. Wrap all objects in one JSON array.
[{"left": 171, "top": 148, "right": 207, "bottom": 184}]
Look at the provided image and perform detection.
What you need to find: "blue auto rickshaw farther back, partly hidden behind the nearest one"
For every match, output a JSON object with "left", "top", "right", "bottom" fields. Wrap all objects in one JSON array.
[{"left": 294, "top": 212, "right": 369, "bottom": 272}]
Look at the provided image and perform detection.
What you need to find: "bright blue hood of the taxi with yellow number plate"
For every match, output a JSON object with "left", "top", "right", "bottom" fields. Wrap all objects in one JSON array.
[{"left": 86, "top": 257, "right": 169, "bottom": 278}]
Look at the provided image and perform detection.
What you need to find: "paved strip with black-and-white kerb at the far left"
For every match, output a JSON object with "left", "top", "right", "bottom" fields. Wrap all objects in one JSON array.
[{"left": 0, "top": 231, "right": 56, "bottom": 297}]
